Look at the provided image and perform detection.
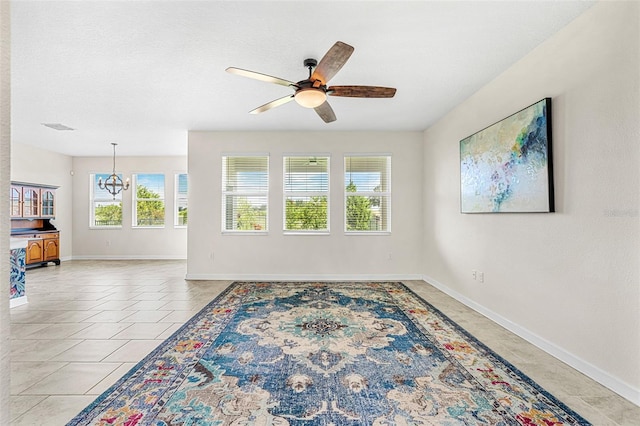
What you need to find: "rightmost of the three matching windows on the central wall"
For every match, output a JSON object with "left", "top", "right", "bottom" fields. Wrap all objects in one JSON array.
[{"left": 344, "top": 155, "right": 391, "bottom": 232}]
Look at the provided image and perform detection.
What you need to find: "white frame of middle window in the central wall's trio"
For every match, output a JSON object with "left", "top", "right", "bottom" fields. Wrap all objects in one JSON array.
[{"left": 282, "top": 152, "right": 331, "bottom": 235}]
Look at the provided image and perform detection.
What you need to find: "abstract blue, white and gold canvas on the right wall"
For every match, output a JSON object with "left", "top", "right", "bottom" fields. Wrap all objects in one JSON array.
[{"left": 460, "top": 98, "right": 554, "bottom": 213}]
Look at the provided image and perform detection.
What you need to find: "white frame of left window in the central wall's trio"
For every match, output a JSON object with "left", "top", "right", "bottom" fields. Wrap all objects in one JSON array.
[{"left": 220, "top": 152, "right": 271, "bottom": 235}]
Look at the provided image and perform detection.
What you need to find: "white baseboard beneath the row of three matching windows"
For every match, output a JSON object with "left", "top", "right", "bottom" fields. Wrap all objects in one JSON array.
[{"left": 185, "top": 273, "right": 422, "bottom": 281}]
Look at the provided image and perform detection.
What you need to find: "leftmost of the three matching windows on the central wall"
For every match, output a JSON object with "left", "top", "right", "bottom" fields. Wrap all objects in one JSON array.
[{"left": 222, "top": 155, "right": 269, "bottom": 232}]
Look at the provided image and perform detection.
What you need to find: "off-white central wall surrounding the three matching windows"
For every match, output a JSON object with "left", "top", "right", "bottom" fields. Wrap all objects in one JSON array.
[{"left": 187, "top": 132, "right": 422, "bottom": 279}]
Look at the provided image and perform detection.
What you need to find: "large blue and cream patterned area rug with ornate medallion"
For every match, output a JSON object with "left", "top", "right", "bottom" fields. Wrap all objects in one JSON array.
[{"left": 69, "top": 282, "right": 589, "bottom": 426}]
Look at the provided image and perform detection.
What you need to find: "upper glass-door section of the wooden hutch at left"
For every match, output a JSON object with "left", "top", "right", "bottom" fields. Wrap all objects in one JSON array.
[{"left": 10, "top": 182, "right": 57, "bottom": 219}]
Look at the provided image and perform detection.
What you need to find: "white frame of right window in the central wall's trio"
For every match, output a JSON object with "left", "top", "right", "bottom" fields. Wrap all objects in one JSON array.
[{"left": 342, "top": 153, "right": 392, "bottom": 235}]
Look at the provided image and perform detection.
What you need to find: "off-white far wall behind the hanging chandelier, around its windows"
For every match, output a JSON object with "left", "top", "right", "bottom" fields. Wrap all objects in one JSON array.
[{"left": 72, "top": 156, "right": 190, "bottom": 259}]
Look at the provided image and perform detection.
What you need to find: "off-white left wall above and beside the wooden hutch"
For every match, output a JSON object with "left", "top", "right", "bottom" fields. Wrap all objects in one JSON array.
[{"left": 11, "top": 142, "right": 73, "bottom": 260}]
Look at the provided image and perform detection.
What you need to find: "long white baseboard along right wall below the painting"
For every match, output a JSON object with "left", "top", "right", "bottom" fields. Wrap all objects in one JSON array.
[{"left": 422, "top": 275, "right": 640, "bottom": 406}]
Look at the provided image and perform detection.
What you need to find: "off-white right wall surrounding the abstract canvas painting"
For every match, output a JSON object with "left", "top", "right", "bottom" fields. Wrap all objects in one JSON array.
[{"left": 423, "top": 2, "right": 640, "bottom": 404}]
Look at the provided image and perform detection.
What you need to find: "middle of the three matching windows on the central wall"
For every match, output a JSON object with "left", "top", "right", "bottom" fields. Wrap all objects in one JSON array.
[{"left": 284, "top": 156, "right": 329, "bottom": 232}]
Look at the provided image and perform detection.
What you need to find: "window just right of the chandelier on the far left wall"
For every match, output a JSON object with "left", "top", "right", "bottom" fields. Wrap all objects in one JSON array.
[{"left": 133, "top": 173, "right": 164, "bottom": 228}]
